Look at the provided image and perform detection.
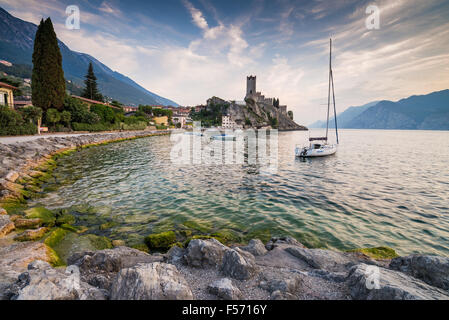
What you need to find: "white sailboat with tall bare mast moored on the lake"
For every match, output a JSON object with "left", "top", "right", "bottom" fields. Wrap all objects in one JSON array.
[{"left": 295, "top": 39, "right": 339, "bottom": 158}]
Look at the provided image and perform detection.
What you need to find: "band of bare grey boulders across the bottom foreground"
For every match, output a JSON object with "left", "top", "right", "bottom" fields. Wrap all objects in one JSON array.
[{"left": 0, "top": 237, "right": 449, "bottom": 300}]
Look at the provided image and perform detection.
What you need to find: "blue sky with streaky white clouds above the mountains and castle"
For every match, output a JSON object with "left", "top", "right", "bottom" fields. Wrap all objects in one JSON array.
[{"left": 0, "top": 0, "right": 449, "bottom": 125}]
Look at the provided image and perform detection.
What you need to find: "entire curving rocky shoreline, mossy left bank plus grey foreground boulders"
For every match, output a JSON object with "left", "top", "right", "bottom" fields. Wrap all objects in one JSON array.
[{"left": 0, "top": 131, "right": 449, "bottom": 300}]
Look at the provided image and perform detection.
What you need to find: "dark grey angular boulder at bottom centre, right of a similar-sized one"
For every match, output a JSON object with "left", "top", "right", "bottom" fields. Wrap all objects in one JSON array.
[{"left": 221, "top": 248, "right": 258, "bottom": 280}]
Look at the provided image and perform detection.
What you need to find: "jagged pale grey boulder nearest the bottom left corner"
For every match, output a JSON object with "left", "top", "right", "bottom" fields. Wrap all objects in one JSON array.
[{"left": 11, "top": 261, "right": 105, "bottom": 300}]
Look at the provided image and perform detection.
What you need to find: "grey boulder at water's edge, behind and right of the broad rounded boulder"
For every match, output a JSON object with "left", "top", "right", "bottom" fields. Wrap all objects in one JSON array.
[{"left": 184, "top": 239, "right": 229, "bottom": 268}]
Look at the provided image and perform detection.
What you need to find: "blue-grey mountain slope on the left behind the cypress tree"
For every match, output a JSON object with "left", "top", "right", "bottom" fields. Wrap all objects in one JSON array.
[{"left": 0, "top": 7, "right": 178, "bottom": 106}]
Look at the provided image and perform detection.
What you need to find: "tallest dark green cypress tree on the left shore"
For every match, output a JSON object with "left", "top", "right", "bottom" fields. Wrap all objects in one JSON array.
[{"left": 31, "top": 18, "right": 66, "bottom": 111}]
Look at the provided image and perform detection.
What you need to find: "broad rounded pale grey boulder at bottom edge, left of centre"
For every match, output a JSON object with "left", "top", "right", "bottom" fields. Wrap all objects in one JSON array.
[{"left": 110, "top": 262, "right": 193, "bottom": 300}]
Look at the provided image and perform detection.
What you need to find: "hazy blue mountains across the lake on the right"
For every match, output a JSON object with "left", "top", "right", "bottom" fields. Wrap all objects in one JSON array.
[{"left": 309, "top": 90, "right": 449, "bottom": 130}]
